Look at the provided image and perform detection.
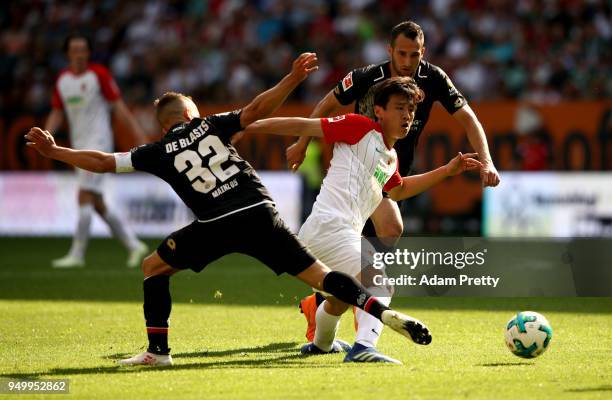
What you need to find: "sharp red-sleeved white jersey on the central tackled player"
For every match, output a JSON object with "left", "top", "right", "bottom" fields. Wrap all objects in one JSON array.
[{"left": 311, "top": 114, "right": 402, "bottom": 234}]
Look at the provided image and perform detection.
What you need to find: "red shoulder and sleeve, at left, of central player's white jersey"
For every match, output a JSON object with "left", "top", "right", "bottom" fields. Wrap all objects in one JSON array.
[{"left": 321, "top": 114, "right": 382, "bottom": 144}]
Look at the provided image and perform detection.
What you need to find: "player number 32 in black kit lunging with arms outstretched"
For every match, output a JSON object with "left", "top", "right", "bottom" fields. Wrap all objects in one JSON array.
[{"left": 25, "top": 53, "right": 431, "bottom": 365}]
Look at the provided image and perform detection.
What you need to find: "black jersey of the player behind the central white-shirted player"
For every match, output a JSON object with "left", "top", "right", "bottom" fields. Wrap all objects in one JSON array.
[{"left": 334, "top": 60, "right": 467, "bottom": 176}]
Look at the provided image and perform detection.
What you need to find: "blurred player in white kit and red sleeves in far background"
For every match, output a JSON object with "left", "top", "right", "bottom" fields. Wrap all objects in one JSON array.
[{"left": 45, "top": 34, "right": 148, "bottom": 268}]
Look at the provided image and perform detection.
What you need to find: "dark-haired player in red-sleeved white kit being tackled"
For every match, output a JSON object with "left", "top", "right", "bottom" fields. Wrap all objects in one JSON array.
[{"left": 245, "top": 77, "right": 482, "bottom": 363}]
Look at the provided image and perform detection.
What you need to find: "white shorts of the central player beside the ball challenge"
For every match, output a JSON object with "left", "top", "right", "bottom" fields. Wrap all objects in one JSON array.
[{"left": 298, "top": 215, "right": 374, "bottom": 276}]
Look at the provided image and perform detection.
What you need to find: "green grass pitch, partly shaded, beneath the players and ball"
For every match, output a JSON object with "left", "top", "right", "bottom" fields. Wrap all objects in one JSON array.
[{"left": 0, "top": 238, "right": 612, "bottom": 400}]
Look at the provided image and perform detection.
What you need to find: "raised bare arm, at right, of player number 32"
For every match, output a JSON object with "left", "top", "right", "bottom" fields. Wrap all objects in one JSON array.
[{"left": 240, "top": 53, "right": 319, "bottom": 127}]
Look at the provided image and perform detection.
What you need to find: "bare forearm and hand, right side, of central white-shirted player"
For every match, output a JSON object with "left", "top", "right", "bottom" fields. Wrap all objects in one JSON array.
[{"left": 389, "top": 153, "right": 482, "bottom": 201}]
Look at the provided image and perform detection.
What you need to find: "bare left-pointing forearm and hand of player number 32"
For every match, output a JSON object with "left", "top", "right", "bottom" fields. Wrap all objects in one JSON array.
[{"left": 25, "top": 127, "right": 116, "bottom": 172}]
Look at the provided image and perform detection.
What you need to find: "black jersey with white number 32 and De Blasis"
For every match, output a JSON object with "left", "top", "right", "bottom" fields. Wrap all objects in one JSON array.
[{"left": 131, "top": 110, "right": 272, "bottom": 221}]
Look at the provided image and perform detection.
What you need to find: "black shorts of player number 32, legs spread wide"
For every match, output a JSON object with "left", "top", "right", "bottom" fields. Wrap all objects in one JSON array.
[{"left": 157, "top": 204, "right": 316, "bottom": 275}]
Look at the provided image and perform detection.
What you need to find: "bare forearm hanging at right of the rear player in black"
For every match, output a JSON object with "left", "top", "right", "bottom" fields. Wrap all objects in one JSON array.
[{"left": 453, "top": 104, "right": 500, "bottom": 187}]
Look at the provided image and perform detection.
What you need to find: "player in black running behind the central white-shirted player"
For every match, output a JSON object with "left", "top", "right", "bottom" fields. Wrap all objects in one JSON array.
[{"left": 287, "top": 21, "right": 499, "bottom": 346}]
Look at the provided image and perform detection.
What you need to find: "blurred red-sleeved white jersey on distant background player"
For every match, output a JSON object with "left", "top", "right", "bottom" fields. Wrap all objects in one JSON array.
[{"left": 51, "top": 64, "right": 121, "bottom": 152}]
